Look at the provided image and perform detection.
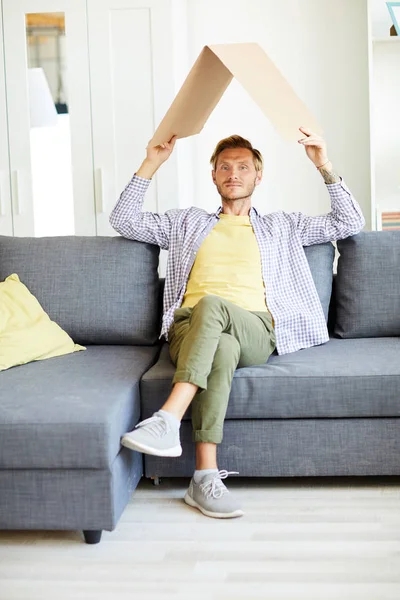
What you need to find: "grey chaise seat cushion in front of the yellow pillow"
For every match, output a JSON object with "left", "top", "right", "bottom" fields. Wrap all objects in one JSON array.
[{"left": 0, "top": 346, "right": 159, "bottom": 469}]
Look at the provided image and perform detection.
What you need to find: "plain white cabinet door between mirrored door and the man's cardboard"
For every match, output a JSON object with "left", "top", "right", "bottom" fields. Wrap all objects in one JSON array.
[{"left": 88, "top": 0, "right": 174, "bottom": 235}]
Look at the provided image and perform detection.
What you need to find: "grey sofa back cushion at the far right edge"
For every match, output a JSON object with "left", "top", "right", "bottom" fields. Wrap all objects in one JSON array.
[{"left": 334, "top": 231, "right": 400, "bottom": 338}]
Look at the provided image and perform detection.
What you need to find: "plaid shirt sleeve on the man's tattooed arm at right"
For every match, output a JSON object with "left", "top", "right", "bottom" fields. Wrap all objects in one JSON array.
[{"left": 287, "top": 180, "right": 365, "bottom": 246}]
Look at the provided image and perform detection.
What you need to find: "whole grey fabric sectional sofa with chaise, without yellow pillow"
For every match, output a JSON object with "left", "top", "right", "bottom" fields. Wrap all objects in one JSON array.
[{"left": 0, "top": 231, "right": 400, "bottom": 543}]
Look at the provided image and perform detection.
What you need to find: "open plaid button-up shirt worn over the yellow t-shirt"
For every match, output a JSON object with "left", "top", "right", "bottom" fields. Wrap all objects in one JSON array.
[{"left": 110, "top": 175, "right": 365, "bottom": 354}]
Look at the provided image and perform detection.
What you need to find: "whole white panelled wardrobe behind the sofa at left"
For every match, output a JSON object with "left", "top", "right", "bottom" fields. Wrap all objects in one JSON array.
[{"left": 0, "top": 0, "right": 176, "bottom": 236}]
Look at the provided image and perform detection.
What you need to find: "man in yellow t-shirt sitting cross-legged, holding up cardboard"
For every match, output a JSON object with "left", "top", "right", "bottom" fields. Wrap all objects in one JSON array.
[{"left": 110, "top": 127, "right": 365, "bottom": 518}]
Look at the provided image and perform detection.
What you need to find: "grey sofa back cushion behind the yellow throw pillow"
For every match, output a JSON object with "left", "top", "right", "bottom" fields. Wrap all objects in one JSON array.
[{"left": 0, "top": 236, "right": 160, "bottom": 345}]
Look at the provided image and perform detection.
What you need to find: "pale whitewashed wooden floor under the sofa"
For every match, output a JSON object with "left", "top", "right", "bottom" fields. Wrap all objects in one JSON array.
[{"left": 0, "top": 477, "right": 400, "bottom": 600}]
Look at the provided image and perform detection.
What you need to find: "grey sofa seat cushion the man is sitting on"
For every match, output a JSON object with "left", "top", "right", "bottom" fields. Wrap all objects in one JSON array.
[{"left": 140, "top": 338, "right": 400, "bottom": 419}]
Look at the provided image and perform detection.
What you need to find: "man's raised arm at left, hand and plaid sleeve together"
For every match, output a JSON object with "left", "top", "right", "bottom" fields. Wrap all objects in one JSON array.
[{"left": 110, "top": 136, "right": 179, "bottom": 250}]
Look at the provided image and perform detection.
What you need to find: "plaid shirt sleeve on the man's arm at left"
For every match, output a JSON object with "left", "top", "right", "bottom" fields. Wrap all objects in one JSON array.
[{"left": 109, "top": 175, "right": 180, "bottom": 250}]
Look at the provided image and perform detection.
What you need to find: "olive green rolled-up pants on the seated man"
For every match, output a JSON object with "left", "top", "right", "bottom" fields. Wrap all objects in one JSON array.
[{"left": 168, "top": 296, "right": 276, "bottom": 444}]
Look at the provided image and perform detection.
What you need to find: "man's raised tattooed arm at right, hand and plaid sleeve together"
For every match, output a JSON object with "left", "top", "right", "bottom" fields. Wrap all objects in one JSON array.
[{"left": 287, "top": 127, "right": 365, "bottom": 246}]
